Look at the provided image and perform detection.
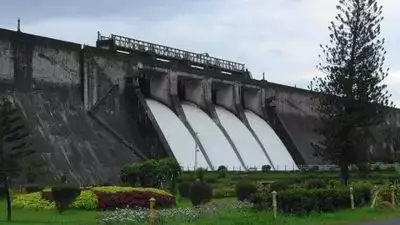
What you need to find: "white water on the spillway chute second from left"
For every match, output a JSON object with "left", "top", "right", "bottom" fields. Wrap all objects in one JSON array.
[{"left": 182, "top": 102, "right": 243, "bottom": 170}]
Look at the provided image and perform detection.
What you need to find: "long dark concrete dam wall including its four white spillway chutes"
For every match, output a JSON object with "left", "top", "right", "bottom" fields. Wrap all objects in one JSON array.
[{"left": 0, "top": 29, "right": 400, "bottom": 184}]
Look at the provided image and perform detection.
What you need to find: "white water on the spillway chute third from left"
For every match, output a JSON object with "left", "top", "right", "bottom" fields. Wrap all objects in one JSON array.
[{"left": 215, "top": 106, "right": 270, "bottom": 169}]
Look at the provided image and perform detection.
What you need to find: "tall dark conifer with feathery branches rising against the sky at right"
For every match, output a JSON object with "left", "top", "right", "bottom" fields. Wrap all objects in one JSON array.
[{"left": 309, "top": 0, "right": 393, "bottom": 185}]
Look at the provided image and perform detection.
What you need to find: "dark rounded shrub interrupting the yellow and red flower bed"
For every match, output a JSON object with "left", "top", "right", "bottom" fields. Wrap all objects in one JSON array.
[{"left": 51, "top": 184, "right": 81, "bottom": 212}]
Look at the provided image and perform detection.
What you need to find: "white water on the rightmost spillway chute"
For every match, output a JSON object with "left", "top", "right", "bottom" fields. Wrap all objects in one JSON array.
[{"left": 245, "top": 110, "right": 298, "bottom": 170}]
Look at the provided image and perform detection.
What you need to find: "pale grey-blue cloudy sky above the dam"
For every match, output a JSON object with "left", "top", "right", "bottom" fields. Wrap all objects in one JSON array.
[{"left": 0, "top": 0, "right": 400, "bottom": 104}]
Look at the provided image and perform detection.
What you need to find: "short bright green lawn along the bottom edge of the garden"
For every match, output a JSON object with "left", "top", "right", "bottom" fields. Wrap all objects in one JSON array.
[{"left": 0, "top": 199, "right": 400, "bottom": 225}]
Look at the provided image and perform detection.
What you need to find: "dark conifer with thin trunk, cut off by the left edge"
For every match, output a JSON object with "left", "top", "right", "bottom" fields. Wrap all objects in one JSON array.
[{"left": 0, "top": 96, "right": 34, "bottom": 221}]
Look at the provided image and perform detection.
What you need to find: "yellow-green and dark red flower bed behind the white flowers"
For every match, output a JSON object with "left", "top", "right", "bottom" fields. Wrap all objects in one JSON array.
[{"left": 13, "top": 187, "right": 175, "bottom": 210}]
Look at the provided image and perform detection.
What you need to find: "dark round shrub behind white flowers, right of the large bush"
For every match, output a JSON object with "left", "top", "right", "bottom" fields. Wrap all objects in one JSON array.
[{"left": 190, "top": 181, "right": 212, "bottom": 206}]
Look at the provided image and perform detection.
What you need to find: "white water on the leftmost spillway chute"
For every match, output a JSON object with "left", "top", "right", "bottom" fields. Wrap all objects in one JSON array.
[{"left": 146, "top": 99, "right": 208, "bottom": 169}]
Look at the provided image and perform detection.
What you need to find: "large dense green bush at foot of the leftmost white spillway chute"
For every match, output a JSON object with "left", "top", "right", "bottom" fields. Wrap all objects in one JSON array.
[{"left": 121, "top": 158, "right": 182, "bottom": 191}]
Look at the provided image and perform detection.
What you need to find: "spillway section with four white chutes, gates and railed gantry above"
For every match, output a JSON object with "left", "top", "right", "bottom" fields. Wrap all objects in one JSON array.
[{"left": 97, "top": 33, "right": 301, "bottom": 170}]
